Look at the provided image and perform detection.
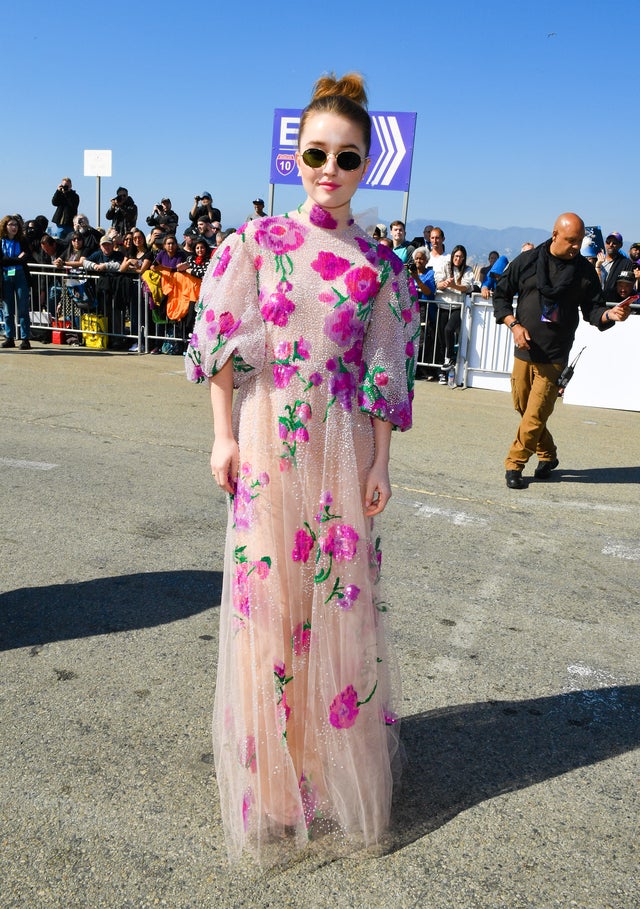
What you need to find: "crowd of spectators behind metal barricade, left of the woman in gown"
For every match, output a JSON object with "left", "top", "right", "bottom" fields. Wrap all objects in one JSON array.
[{"left": 0, "top": 177, "right": 266, "bottom": 353}]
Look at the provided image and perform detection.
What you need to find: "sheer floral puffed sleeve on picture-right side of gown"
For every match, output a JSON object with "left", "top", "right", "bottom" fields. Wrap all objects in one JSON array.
[{"left": 358, "top": 246, "right": 420, "bottom": 430}]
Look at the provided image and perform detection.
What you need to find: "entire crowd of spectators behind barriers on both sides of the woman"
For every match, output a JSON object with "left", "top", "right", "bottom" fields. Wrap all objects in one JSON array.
[{"left": 0, "top": 177, "right": 640, "bottom": 360}]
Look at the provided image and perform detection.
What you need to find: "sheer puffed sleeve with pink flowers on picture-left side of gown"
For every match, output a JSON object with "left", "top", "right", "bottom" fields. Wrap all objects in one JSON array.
[{"left": 185, "top": 232, "right": 265, "bottom": 388}]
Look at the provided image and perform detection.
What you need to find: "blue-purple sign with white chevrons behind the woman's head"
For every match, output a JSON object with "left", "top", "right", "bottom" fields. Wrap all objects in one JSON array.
[{"left": 269, "top": 108, "right": 416, "bottom": 192}]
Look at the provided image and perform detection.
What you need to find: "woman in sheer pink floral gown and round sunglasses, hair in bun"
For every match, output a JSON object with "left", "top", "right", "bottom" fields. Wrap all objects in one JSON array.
[{"left": 187, "top": 75, "right": 419, "bottom": 862}]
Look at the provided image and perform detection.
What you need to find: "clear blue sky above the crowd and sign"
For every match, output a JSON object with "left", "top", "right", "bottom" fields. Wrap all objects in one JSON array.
[{"left": 0, "top": 0, "right": 640, "bottom": 246}]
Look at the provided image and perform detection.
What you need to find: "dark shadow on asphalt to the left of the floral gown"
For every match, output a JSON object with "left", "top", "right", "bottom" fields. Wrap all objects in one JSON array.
[{"left": 0, "top": 571, "right": 222, "bottom": 650}]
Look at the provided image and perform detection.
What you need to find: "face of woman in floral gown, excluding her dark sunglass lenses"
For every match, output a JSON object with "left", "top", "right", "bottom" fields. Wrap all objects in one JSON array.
[{"left": 296, "top": 113, "right": 369, "bottom": 212}]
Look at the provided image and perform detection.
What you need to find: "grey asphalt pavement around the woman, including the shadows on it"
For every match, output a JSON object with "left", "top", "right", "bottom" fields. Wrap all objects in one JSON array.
[{"left": 0, "top": 344, "right": 640, "bottom": 909}]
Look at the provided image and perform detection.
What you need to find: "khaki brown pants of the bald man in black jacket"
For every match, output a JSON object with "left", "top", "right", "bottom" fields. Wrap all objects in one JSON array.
[{"left": 504, "top": 359, "right": 564, "bottom": 470}]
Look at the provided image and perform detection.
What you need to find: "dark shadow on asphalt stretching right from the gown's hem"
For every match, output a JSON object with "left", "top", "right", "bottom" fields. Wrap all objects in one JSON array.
[{"left": 388, "top": 685, "right": 640, "bottom": 852}]
